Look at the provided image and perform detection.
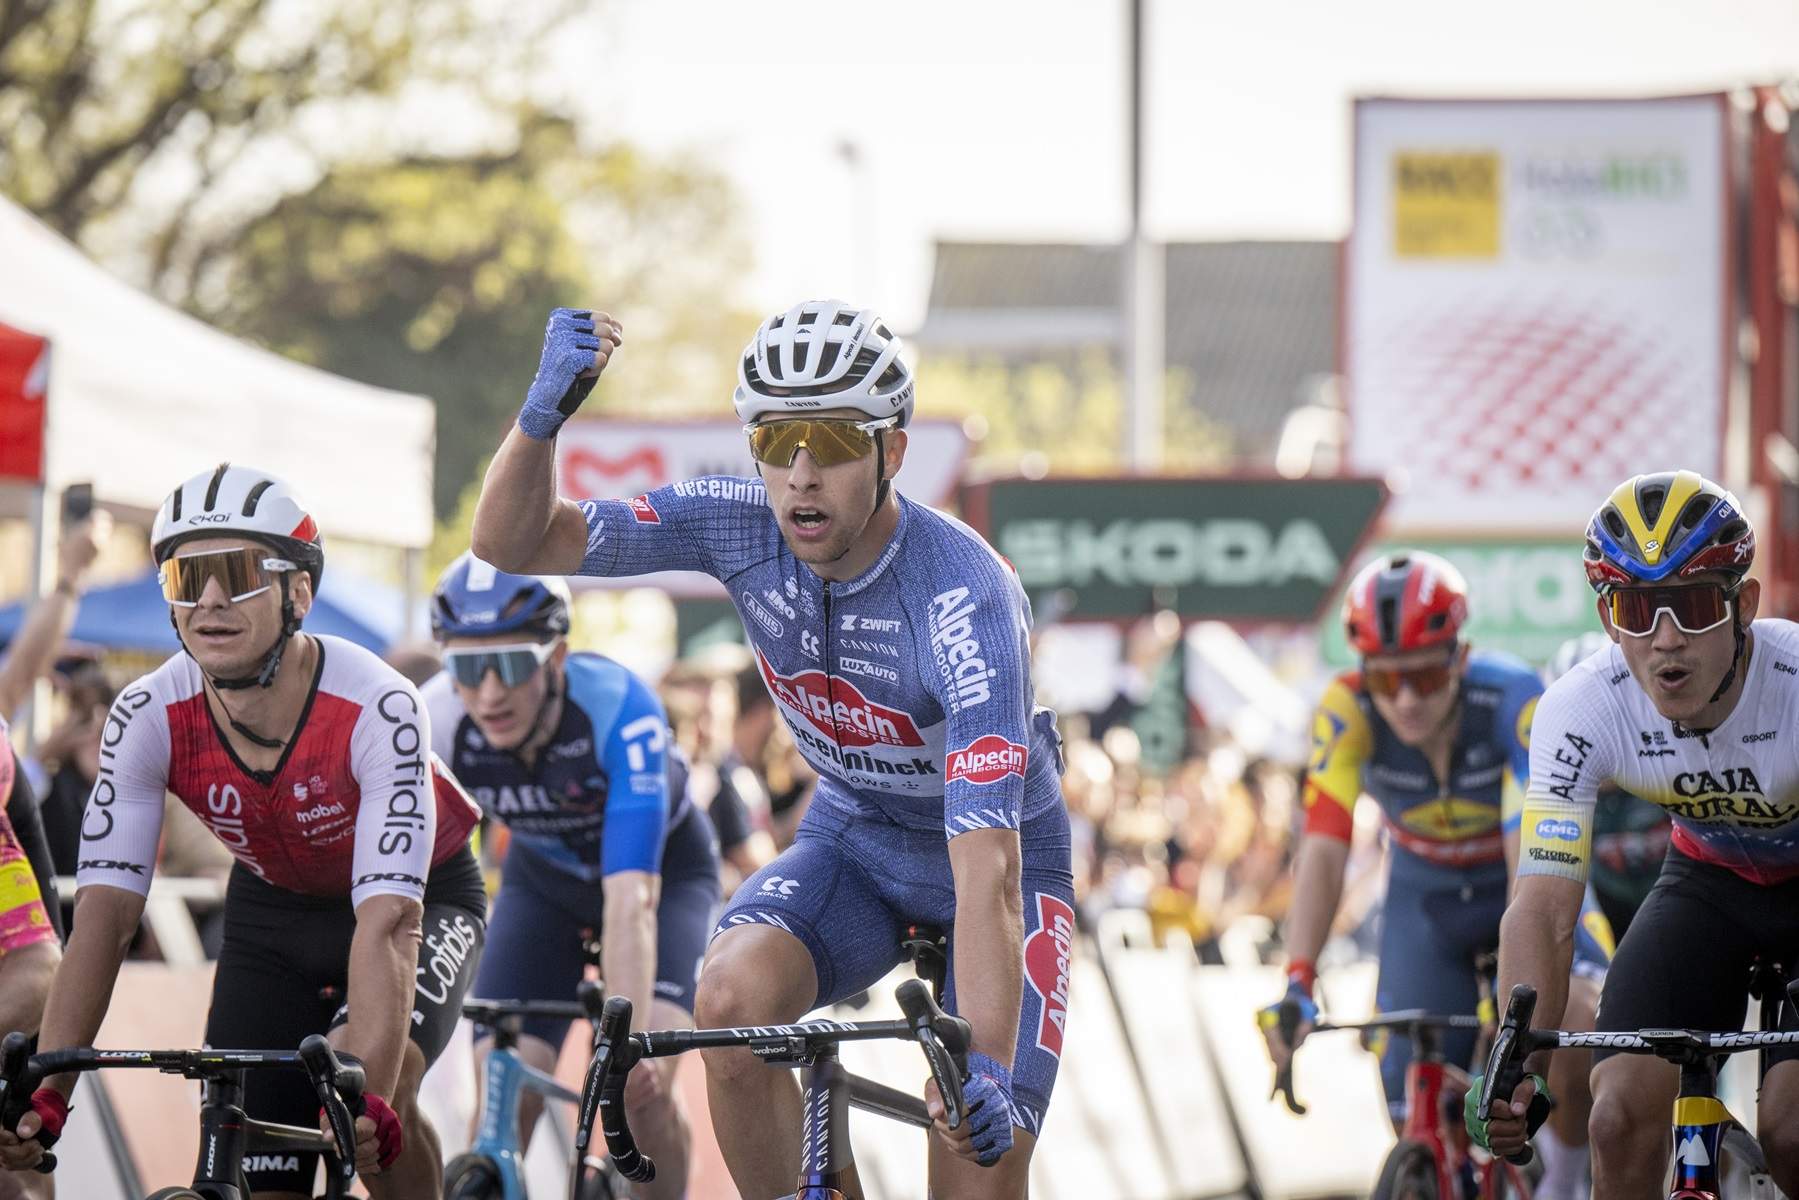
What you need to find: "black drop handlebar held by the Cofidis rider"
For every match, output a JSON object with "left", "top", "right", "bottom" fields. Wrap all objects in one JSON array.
[{"left": 0, "top": 1033, "right": 363, "bottom": 1182}]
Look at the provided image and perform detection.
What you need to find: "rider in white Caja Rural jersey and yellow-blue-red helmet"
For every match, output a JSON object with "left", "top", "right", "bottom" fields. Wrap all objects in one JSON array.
[{"left": 1488, "top": 471, "right": 1799, "bottom": 1200}]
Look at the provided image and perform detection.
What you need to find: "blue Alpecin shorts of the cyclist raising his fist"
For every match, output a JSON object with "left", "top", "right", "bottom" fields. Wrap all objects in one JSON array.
[{"left": 718, "top": 791, "right": 1074, "bottom": 1135}]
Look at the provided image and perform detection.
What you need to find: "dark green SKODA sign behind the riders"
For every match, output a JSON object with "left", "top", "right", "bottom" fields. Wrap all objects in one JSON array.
[{"left": 962, "top": 477, "right": 1387, "bottom": 624}]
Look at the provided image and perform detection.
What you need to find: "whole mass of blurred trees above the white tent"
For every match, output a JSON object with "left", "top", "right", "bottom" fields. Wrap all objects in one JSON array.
[{"left": 0, "top": 0, "right": 754, "bottom": 518}]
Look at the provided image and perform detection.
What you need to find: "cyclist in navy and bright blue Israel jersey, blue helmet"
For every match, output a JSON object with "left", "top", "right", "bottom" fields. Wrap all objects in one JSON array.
[{"left": 421, "top": 554, "right": 718, "bottom": 1198}]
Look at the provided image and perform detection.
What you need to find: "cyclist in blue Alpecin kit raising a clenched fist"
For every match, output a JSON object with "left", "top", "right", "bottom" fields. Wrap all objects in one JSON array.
[{"left": 473, "top": 300, "right": 1074, "bottom": 1200}]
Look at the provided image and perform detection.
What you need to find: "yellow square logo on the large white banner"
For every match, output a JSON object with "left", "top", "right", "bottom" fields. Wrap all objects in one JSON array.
[{"left": 1392, "top": 151, "right": 1499, "bottom": 259}]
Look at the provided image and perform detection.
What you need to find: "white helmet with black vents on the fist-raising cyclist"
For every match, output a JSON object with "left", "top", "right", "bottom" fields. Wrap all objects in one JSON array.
[{"left": 732, "top": 300, "right": 914, "bottom": 426}]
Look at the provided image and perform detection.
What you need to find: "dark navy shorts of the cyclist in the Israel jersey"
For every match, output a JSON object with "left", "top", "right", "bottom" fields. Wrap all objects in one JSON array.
[{"left": 475, "top": 808, "right": 720, "bottom": 1045}]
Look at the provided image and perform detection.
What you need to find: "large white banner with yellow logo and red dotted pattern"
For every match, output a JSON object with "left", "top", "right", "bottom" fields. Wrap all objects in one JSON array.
[{"left": 1342, "top": 95, "right": 1729, "bottom": 533}]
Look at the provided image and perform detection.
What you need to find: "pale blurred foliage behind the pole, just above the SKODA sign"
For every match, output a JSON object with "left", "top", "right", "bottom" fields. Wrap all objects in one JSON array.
[{"left": 917, "top": 349, "right": 1232, "bottom": 477}]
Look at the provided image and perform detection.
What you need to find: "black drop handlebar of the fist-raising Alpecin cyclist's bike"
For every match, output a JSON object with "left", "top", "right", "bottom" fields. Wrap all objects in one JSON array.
[{"left": 574, "top": 979, "right": 971, "bottom": 1184}]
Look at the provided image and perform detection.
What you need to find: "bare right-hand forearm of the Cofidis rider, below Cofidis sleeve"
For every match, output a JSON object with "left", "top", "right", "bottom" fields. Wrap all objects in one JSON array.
[{"left": 335, "top": 896, "right": 423, "bottom": 1099}]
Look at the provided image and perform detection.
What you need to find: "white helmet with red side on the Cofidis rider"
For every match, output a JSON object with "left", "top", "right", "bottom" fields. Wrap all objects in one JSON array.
[{"left": 149, "top": 462, "right": 326, "bottom": 592}]
